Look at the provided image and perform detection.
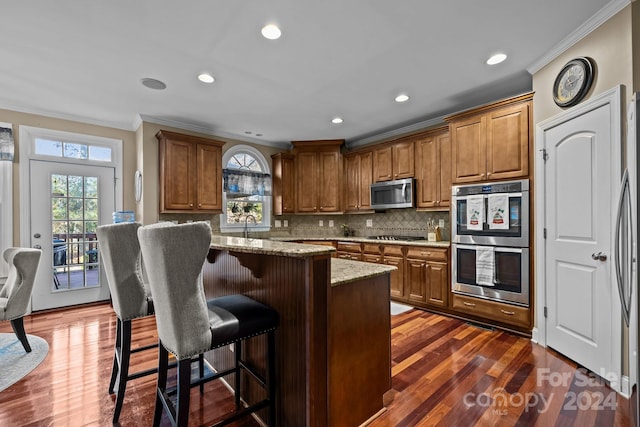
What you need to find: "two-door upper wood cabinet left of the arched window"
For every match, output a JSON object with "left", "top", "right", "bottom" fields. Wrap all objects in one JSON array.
[{"left": 156, "top": 130, "right": 224, "bottom": 213}]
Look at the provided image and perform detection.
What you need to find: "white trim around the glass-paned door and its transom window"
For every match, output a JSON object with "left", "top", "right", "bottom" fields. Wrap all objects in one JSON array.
[{"left": 19, "top": 126, "right": 123, "bottom": 251}]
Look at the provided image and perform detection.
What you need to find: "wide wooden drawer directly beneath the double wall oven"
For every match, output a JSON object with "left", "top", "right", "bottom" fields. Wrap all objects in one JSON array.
[{"left": 453, "top": 294, "right": 530, "bottom": 328}]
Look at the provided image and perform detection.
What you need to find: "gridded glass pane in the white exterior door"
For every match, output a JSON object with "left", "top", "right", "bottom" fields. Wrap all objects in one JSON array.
[{"left": 51, "top": 175, "right": 99, "bottom": 291}]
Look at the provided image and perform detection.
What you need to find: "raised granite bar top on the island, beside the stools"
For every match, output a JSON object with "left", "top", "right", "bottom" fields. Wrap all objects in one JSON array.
[{"left": 210, "top": 235, "right": 335, "bottom": 258}]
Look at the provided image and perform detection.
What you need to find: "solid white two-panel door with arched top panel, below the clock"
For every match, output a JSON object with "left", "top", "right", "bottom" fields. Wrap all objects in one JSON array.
[{"left": 544, "top": 104, "right": 620, "bottom": 379}]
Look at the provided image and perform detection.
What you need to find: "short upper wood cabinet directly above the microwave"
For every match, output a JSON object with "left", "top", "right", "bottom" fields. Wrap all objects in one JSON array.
[{"left": 373, "top": 138, "right": 414, "bottom": 182}]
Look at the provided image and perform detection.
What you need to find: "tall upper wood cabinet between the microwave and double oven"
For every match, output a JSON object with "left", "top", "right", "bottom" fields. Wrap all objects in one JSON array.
[{"left": 415, "top": 128, "right": 451, "bottom": 208}]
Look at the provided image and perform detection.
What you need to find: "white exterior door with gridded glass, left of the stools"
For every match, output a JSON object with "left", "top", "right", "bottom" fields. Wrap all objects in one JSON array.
[{"left": 29, "top": 160, "right": 115, "bottom": 310}]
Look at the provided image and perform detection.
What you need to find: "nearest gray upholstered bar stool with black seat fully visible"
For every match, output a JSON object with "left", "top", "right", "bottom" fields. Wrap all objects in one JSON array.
[{"left": 138, "top": 222, "right": 278, "bottom": 426}]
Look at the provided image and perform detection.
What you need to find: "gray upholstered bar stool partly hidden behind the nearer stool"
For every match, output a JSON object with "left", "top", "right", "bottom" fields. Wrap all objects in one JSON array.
[{"left": 96, "top": 222, "right": 204, "bottom": 423}]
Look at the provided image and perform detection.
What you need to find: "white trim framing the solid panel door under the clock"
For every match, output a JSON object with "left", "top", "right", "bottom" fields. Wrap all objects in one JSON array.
[{"left": 531, "top": 85, "right": 629, "bottom": 396}]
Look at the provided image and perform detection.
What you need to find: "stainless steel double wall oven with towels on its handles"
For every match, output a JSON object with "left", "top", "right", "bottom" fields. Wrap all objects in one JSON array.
[{"left": 451, "top": 180, "right": 530, "bottom": 307}]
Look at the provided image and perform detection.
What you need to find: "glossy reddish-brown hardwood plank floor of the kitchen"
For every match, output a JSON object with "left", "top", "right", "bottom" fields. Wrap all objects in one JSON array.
[{"left": 0, "top": 304, "right": 631, "bottom": 427}]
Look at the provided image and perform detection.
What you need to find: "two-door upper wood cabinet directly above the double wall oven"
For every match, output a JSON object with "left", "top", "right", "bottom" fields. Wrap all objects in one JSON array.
[{"left": 446, "top": 94, "right": 533, "bottom": 183}]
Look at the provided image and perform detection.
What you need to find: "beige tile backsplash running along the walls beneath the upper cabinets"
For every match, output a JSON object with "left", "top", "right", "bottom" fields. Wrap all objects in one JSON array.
[{"left": 160, "top": 209, "right": 451, "bottom": 240}]
